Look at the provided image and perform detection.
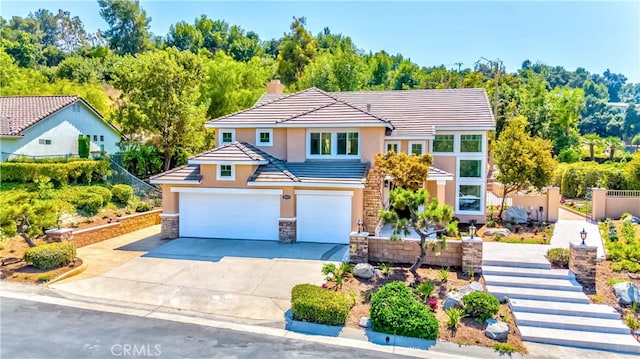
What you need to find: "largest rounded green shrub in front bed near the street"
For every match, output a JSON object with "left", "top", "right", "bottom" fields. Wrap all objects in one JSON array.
[{"left": 370, "top": 282, "right": 440, "bottom": 340}]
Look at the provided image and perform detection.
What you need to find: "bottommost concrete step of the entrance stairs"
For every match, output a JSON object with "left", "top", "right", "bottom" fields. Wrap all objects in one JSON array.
[{"left": 518, "top": 325, "right": 640, "bottom": 358}]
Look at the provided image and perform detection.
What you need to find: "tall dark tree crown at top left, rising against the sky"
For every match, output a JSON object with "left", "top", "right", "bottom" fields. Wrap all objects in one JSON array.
[{"left": 98, "top": 0, "right": 151, "bottom": 55}]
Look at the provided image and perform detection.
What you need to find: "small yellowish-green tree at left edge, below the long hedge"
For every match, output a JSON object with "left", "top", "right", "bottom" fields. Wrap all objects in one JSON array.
[{"left": 0, "top": 192, "right": 58, "bottom": 247}]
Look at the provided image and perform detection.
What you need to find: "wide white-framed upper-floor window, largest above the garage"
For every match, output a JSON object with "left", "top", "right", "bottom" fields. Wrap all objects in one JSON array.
[{"left": 309, "top": 131, "right": 360, "bottom": 157}]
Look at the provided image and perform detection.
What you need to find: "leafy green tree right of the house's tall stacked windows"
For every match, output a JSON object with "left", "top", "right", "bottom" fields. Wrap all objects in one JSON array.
[{"left": 493, "top": 116, "right": 556, "bottom": 217}]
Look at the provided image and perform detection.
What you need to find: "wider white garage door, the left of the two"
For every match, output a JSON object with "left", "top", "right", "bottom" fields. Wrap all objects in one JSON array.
[{"left": 179, "top": 190, "right": 280, "bottom": 241}]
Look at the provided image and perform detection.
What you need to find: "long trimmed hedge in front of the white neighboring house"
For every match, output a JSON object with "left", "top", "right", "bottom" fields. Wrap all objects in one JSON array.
[{"left": 0, "top": 160, "right": 110, "bottom": 184}]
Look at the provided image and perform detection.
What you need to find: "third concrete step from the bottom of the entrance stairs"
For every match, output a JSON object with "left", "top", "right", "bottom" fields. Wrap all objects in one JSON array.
[{"left": 509, "top": 298, "right": 620, "bottom": 320}]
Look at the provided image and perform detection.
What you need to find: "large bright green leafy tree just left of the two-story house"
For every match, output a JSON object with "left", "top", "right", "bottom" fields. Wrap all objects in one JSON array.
[{"left": 114, "top": 48, "right": 205, "bottom": 171}]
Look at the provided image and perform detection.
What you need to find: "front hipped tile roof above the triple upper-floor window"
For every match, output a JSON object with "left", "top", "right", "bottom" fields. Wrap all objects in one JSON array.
[{"left": 207, "top": 88, "right": 392, "bottom": 128}]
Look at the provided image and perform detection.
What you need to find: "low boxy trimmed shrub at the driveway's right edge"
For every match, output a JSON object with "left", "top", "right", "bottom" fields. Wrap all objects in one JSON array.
[{"left": 291, "top": 284, "right": 351, "bottom": 325}]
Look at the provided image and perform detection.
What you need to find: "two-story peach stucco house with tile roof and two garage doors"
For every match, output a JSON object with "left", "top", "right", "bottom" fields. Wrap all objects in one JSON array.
[{"left": 151, "top": 82, "right": 495, "bottom": 243}]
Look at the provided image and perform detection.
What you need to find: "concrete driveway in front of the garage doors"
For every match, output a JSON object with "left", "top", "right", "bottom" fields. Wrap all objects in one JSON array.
[{"left": 51, "top": 238, "right": 349, "bottom": 325}]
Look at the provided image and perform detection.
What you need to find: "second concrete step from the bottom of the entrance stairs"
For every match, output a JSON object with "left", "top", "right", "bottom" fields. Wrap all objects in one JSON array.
[{"left": 513, "top": 311, "right": 630, "bottom": 335}]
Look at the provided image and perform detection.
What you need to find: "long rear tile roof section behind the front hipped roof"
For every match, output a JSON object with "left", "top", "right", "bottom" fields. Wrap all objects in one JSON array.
[{"left": 254, "top": 88, "right": 495, "bottom": 136}]
